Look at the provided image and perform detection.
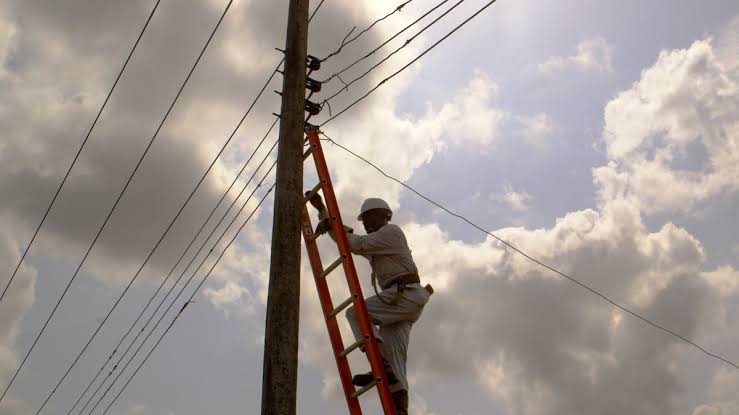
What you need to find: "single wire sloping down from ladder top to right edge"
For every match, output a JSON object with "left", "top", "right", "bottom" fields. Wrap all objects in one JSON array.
[{"left": 321, "top": 132, "right": 739, "bottom": 369}]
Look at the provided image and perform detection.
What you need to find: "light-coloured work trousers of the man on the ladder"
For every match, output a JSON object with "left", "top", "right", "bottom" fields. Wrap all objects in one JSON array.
[{"left": 346, "top": 283, "right": 431, "bottom": 392}]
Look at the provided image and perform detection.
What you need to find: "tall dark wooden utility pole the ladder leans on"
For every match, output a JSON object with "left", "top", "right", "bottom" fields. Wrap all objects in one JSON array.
[{"left": 262, "top": 0, "right": 308, "bottom": 415}]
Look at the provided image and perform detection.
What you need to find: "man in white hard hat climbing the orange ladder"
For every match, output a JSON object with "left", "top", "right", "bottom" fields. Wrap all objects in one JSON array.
[{"left": 310, "top": 195, "right": 433, "bottom": 415}]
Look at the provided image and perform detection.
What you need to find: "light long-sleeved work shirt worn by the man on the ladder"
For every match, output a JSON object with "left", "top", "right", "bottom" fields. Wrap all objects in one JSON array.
[{"left": 318, "top": 209, "right": 418, "bottom": 287}]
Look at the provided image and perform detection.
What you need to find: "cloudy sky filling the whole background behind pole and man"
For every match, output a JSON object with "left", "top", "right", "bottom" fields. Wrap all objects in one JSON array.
[{"left": 0, "top": 0, "right": 739, "bottom": 415}]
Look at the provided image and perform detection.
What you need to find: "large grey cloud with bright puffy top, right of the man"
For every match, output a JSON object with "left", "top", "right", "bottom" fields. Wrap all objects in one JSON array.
[{"left": 405, "top": 199, "right": 718, "bottom": 415}]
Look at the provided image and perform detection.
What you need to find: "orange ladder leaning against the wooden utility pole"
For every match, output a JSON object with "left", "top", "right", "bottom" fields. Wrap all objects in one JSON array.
[{"left": 301, "top": 124, "right": 395, "bottom": 415}]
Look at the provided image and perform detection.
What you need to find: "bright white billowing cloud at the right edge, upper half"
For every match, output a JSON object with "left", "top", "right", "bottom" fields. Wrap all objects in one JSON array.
[{"left": 594, "top": 33, "right": 739, "bottom": 213}]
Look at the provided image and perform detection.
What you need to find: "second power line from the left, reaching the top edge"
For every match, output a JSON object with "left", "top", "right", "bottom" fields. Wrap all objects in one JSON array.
[{"left": 0, "top": 0, "right": 233, "bottom": 402}]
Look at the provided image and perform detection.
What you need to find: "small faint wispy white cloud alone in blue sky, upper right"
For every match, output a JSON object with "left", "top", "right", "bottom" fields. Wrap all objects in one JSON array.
[{"left": 537, "top": 37, "right": 613, "bottom": 76}]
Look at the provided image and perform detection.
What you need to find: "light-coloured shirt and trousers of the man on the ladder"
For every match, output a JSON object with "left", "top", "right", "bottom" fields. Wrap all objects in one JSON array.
[{"left": 319, "top": 210, "right": 431, "bottom": 392}]
